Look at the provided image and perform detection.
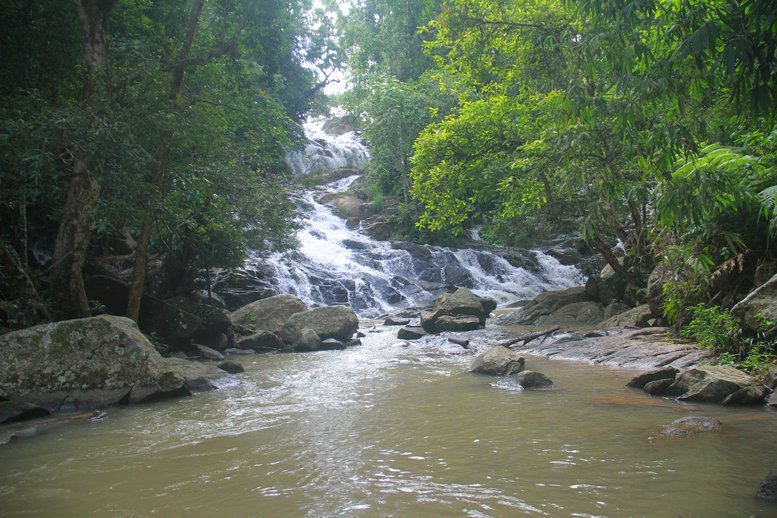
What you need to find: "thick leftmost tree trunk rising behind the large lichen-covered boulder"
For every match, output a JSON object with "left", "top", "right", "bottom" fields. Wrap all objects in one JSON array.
[{"left": 52, "top": 0, "right": 116, "bottom": 318}]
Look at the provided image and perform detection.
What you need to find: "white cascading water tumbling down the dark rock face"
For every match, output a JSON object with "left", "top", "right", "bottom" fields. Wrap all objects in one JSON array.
[{"left": 241, "top": 121, "right": 582, "bottom": 318}]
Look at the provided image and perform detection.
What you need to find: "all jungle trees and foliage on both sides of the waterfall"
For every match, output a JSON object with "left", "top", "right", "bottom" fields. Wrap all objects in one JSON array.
[{"left": 0, "top": 0, "right": 777, "bottom": 370}]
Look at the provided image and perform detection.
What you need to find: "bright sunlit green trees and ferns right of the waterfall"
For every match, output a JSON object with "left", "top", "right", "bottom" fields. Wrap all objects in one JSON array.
[{"left": 344, "top": 0, "right": 777, "bottom": 368}]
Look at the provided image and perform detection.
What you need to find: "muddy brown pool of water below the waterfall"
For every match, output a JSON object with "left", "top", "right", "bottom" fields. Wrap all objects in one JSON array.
[{"left": 0, "top": 328, "right": 777, "bottom": 517}]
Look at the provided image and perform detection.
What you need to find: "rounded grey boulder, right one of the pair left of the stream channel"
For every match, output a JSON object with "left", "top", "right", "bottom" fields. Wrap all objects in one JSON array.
[{"left": 280, "top": 306, "right": 359, "bottom": 344}]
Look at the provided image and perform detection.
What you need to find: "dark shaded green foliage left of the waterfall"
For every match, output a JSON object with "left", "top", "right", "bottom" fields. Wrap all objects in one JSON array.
[{"left": 0, "top": 0, "right": 328, "bottom": 324}]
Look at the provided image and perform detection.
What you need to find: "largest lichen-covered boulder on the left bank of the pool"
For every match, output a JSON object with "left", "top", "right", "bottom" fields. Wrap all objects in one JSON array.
[{"left": 0, "top": 316, "right": 190, "bottom": 411}]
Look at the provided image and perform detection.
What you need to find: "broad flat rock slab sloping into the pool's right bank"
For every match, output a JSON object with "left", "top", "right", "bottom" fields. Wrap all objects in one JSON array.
[{"left": 520, "top": 327, "right": 709, "bottom": 370}]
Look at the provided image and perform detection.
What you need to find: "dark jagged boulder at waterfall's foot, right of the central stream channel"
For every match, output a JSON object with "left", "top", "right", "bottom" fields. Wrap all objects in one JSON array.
[{"left": 421, "top": 288, "right": 493, "bottom": 333}]
